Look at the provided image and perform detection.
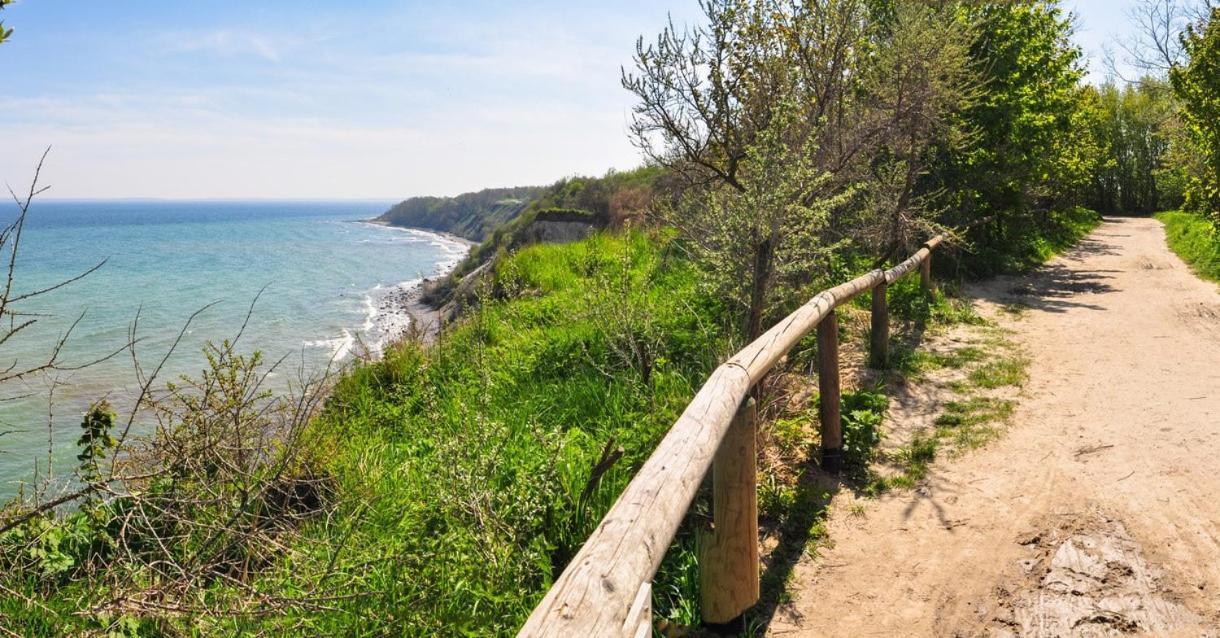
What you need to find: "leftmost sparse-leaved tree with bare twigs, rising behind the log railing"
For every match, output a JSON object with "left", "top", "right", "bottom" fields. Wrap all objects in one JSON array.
[{"left": 622, "top": 0, "right": 864, "bottom": 339}]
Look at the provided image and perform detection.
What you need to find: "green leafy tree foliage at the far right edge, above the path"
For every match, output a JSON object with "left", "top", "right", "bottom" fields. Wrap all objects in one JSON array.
[{"left": 1169, "top": 7, "right": 1220, "bottom": 219}]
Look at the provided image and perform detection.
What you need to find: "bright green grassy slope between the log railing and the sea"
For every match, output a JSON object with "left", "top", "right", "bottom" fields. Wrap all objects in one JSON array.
[{"left": 242, "top": 229, "right": 720, "bottom": 636}]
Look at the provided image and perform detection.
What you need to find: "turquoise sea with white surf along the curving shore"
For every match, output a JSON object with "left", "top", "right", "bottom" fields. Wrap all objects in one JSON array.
[{"left": 0, "top": 201, "right": 466, "bottom": 495}]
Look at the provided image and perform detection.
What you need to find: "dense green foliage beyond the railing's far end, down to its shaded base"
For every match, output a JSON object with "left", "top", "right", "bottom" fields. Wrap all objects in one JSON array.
[{"left": 922, "top": 1, "right": 1104, "bottom": 274}]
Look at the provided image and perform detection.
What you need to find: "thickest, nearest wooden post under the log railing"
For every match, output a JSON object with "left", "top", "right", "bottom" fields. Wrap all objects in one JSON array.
[{"left": 699, "top": 398, "right": 759, "bottom": 625}]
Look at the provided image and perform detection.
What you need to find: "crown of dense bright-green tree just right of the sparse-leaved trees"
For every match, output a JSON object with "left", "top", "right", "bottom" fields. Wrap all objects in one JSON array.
[{"left": 935, "top": 1, "right": 1088, "bottom": 222}]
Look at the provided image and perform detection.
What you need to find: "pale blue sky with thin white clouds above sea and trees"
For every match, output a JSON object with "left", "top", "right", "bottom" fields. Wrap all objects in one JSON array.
[{"left": 0, "top": 0, "right": 1132, "bottom": 200}]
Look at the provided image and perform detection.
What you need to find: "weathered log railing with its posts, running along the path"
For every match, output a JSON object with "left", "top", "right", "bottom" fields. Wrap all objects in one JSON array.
[{"left": 517, "top": 217, "right": 991, "bottom": 638}]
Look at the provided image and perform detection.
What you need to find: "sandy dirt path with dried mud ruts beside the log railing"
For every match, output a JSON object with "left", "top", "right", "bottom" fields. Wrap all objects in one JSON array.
[{"left": 770, "top": 218, "right": 1220, "bottom": 637}]
